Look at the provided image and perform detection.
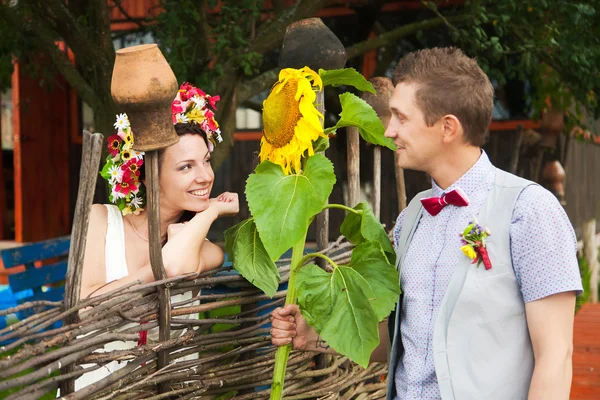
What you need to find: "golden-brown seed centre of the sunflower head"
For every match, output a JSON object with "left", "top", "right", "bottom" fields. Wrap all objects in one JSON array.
[{"left": 263, "top": 79, "right": 302, "bottom": 147}]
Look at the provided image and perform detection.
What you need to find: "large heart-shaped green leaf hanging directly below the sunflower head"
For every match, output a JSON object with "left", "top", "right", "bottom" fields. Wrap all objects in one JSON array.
[{"left": 246, "top": 154, "right": 335, "bottom": 261}]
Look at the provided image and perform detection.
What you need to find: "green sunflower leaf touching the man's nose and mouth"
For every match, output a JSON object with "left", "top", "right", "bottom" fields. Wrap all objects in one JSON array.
[{"left": 334, "top": 93, "right": 396, "bottom": 150}]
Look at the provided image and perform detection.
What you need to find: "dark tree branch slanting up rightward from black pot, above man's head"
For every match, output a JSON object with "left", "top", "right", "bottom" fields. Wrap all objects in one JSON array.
[{"left": 346, "top": 14, "right": 471, "bottom": 59}]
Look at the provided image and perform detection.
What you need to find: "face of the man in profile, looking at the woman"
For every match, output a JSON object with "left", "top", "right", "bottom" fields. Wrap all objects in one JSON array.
[{"left": 385, "top": 82, "right": 443, "bottom": 172}]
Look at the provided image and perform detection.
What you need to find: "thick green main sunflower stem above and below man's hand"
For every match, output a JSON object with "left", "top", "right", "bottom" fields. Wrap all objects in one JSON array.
[{"left": 271, "top": 233, "right": 306, "bottom": 400}]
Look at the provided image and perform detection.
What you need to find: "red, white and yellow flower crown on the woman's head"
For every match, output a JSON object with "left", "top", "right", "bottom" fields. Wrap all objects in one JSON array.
[{"left": 100, "top": 82, "right": 223, "bottom": 215}]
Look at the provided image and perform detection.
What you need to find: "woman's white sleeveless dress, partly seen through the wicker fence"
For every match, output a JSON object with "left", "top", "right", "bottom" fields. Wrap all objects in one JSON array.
[{"left": 75, "top": 204, "right": 200, "bottom": 390}]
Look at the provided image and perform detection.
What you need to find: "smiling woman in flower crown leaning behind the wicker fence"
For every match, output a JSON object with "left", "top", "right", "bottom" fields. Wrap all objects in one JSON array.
[{"left": 76, "top": 84, "right": 239, "bottom": 389}]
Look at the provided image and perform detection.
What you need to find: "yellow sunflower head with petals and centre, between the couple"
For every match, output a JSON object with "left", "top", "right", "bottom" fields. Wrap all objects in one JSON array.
[{"left": 260, "top": 67, "right": 325, "bottom": 175}]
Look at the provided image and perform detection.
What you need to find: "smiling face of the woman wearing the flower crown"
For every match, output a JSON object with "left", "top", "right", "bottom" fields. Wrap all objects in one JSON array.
[{"left": 159, "top": 134, "right": 215, "bottom": 212}]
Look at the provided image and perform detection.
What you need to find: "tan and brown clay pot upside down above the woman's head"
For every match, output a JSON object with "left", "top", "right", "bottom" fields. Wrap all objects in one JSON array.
[{"left": 110, "top": 44, "right": 179, "bottom": 151}]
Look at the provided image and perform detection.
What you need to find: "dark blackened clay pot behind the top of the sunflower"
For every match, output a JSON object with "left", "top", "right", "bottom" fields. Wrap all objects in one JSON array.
[{"left": 279, "top": 18, "right": 346, "bottom": 72}]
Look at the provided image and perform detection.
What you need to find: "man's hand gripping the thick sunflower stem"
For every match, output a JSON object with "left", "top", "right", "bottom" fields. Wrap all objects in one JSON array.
[{"left": 271, "top": 304, "right": 319, "bottom": 350}]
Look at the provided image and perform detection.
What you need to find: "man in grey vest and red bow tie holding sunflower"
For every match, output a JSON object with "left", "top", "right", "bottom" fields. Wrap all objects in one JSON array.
[{"left": 271, "top": 48, "right": 582, "bottom": 400}]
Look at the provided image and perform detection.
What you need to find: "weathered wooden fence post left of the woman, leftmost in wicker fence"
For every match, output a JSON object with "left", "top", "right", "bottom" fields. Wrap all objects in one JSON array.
[{"left": 60, "top": 131, "right": 104, "bottom": 396}]
